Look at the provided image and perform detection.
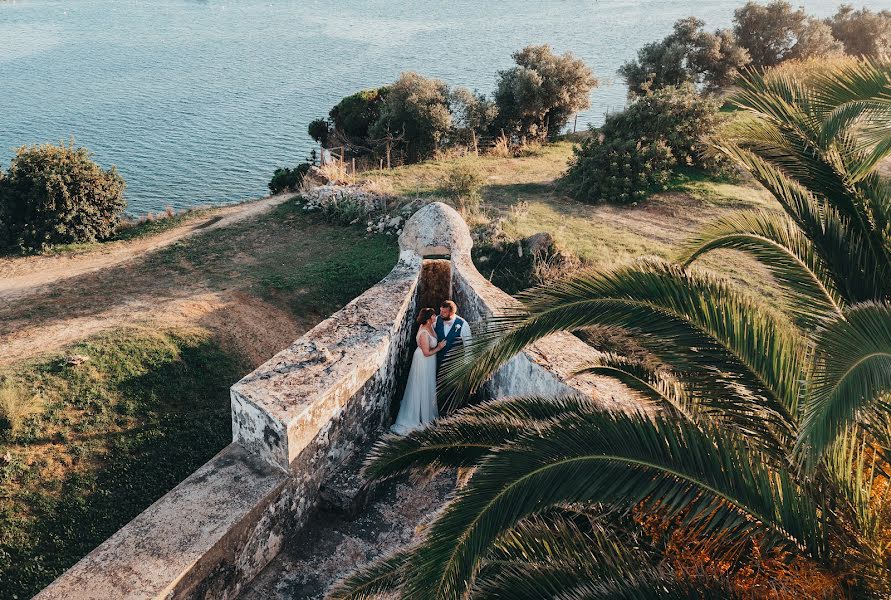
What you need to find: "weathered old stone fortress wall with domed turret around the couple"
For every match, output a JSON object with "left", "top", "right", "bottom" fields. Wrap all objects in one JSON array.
[{"left": 36, "top": 203, "right": 630, "bottom": 600}]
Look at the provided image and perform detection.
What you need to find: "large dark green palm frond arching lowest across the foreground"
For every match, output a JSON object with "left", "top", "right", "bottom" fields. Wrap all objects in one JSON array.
[{"left": 403, "top": 413, "right": 825, "bottom": 600}]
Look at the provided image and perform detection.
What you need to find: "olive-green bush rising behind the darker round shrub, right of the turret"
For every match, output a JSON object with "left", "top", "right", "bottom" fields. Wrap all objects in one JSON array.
[{"left": 600, "top": 84, "right": 725, "bottom": 170}]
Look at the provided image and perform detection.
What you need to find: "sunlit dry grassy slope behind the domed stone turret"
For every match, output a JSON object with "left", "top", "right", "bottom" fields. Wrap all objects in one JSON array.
[{"left": 371, "top": 141, "right": 782, "bottom": 301}]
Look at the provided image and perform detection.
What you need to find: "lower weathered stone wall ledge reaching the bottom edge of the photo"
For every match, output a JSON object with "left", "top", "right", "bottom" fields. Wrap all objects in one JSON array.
[{"left": 35, "top": 444, "right": 286, "bottom": 600}]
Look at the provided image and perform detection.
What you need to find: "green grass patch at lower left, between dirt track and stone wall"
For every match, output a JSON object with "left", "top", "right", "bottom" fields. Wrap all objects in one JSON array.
[{"left": 0, "top": 329, "right": 247, "bottom": 598}]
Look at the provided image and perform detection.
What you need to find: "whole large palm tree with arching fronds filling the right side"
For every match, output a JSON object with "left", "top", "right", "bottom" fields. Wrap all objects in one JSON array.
[{"left": 332, "top": 63, "right": 891, "bottom": 599}]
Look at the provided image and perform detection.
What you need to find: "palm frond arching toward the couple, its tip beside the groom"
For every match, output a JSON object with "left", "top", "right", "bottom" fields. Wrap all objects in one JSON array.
[{"left": 442, "top": 261, "right": 804, "bottom": 432}]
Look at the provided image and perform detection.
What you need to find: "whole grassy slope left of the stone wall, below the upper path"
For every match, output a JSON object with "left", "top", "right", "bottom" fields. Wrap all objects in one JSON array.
[{"left": 0, "top": 202, "right": 397, "bottom": 599}]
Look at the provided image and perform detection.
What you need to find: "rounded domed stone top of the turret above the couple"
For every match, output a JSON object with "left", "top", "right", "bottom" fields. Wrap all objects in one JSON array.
[{"left": 399, "top": 202, "right": 473, "bottom": 260}]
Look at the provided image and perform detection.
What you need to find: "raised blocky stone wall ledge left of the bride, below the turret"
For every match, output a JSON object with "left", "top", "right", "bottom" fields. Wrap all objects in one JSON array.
[{"left": 231, "top": 259, "right": 421, "bottom": 470}]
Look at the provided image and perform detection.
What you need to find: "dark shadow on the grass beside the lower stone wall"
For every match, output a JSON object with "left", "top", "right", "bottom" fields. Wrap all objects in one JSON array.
[{"left": 0, "top": 339, "right": 245, "bottom": 598}]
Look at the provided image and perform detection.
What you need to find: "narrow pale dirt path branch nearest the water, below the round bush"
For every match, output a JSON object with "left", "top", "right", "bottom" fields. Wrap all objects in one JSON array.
[{"left": 0, "top": 194, "right": 293, "bottom": 302}]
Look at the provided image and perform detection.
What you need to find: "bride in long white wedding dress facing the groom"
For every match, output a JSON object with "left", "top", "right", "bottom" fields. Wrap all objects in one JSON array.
[{"left": 390, "top": 308, "right": 445, "bottom": 435}]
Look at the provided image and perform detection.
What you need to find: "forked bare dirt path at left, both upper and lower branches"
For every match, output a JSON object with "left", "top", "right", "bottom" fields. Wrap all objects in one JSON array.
[{"left": 0, "top": 194, "right": 311, "bottom": 366}]
